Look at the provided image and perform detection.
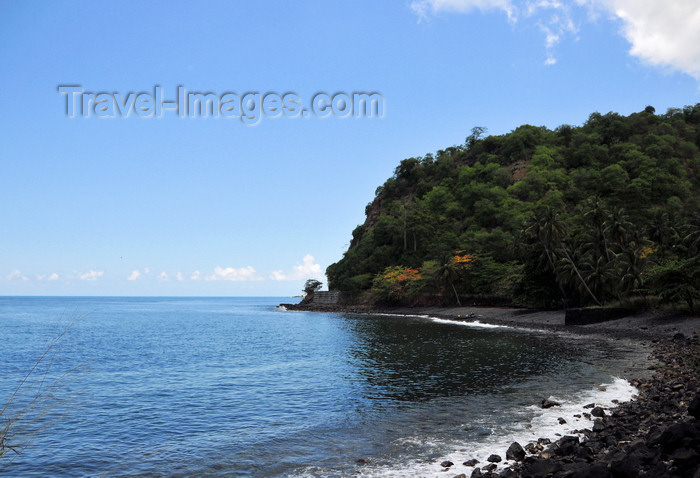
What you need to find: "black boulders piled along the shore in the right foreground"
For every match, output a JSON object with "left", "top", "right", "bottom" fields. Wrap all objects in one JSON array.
[{"left": 492, "top": 333, "right": 700, "bottom": 478}]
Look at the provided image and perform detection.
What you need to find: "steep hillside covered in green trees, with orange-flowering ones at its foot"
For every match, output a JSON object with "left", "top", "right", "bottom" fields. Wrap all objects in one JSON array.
[{"left": 326, "top": 104, "right": 700, "bottom": 309}]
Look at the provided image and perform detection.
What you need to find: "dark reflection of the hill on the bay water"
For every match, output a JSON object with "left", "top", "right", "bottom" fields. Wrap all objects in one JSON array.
[{"left": 346, "top": 316, "right": 586, "bottom": 401}]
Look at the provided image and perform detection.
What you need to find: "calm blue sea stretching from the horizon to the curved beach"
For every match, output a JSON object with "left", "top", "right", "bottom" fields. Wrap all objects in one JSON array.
[{"left": 0, "top": 297, "right": 634, "bottom": 477}]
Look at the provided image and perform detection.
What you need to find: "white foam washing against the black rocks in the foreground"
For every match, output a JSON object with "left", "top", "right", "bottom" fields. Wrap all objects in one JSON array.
[{"left": 348, "top": 377, "right": 637, "bottom": 478}]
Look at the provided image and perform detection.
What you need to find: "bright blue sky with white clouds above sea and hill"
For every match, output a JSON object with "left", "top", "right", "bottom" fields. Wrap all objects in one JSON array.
[{"left": 0, "top": 0, "right": 700, "bottom": 296}]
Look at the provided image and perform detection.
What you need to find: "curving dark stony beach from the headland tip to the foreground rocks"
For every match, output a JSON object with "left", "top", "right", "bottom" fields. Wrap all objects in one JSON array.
[{"left": 282, "top": 304, "right": 700, "bottom": 478}]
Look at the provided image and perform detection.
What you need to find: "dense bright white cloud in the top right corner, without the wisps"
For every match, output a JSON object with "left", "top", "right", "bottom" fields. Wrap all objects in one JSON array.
[{"left": 588, "top": 0, "right": 700, "bottom": 79}]
